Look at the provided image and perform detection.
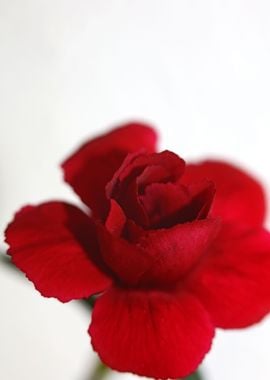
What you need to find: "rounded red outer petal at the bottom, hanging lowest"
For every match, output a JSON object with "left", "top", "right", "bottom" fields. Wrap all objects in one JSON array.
[{"left": 89, "top": 288, "right": 214, "bottom": 379}]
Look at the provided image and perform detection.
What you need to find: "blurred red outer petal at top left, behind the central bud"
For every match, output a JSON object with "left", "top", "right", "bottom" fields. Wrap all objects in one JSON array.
[{"left": 62, "top": 123, "right": 157, "bottom": 218}]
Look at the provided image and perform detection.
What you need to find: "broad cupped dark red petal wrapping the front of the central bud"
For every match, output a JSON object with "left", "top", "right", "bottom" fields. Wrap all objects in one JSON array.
[{"left": 98, "top": 220, "right": 219, "bottom": 288}]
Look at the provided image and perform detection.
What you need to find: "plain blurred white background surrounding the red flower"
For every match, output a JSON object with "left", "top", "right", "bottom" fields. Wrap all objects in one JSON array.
[{"left": 0, "top": 0, "right": 270, "bottom": 380}]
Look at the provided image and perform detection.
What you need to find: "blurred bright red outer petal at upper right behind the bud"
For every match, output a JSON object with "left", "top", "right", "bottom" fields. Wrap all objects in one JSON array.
[{"left": 183, "top": 161, "right": 266, "bottom": 227}]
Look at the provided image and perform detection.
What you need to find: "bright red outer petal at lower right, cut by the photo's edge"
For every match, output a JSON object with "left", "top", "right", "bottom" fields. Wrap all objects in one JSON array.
[{"left": 186, "top": 229, "right": 270, "bottom": 328}]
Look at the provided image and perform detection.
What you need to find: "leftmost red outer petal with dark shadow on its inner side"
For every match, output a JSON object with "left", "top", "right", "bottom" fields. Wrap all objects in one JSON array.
[{"left": 6, "top": 202, "right": 110, "bottom": 302}]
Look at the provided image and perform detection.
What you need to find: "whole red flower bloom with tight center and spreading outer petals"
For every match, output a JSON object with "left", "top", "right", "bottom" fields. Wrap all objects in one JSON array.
[{"left": 6, "top": 123, "right": 270, "bottom": 379}]
